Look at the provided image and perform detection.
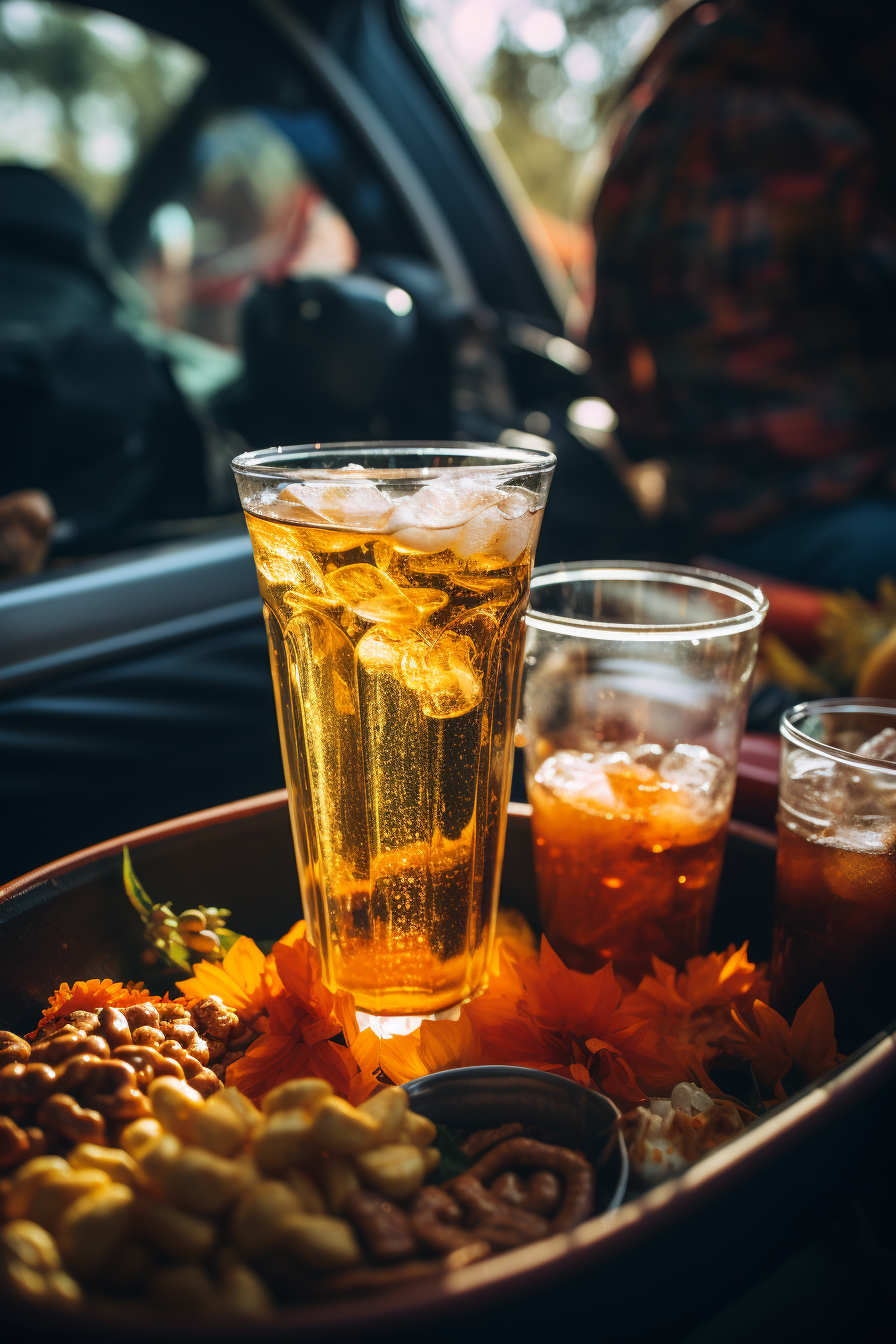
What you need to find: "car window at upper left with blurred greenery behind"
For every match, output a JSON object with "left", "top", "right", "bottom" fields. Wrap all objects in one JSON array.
[{"left": 0, "top": 0, "right": 365, "bottom": 347}]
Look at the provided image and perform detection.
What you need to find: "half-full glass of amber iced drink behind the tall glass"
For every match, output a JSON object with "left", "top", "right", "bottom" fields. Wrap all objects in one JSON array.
[{"left": 523, "top": 562, "right": 767, "bottom": 981}]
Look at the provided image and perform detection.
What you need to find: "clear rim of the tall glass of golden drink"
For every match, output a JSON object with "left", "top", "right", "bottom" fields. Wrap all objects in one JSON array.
[{"left": 230, "top": 439, "right": 556, "bottom": 484}]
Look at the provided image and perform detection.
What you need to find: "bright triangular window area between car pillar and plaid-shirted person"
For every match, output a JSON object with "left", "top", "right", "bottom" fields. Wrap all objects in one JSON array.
[{"left": 404, "top": 0, "right": 666, "bottom": 335}]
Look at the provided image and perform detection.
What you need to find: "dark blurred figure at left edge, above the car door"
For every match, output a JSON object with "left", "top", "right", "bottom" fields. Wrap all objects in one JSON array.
[{"left": 0, "top": 164, "right": 208, "bottom": 561}]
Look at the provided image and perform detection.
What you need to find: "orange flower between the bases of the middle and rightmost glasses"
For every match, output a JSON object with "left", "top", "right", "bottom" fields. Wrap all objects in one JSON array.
[{"left": 622, "top": 942, "right": 768, "bottom": 1062}]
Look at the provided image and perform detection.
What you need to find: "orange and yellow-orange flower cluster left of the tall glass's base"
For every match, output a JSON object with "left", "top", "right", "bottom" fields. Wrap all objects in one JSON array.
[{"left": 177, "top": 919, "right": 379, "bottom": 1105}]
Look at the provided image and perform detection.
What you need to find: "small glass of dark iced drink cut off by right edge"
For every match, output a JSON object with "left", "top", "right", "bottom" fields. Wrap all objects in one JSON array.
[{"left": 771, "top": 699, "right": 896, "bottom": 1050}]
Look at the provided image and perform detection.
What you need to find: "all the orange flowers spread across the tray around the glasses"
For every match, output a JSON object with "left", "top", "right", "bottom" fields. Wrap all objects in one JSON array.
[{"left": 35, "top": 917, "right": 842, "bottom": 1110}]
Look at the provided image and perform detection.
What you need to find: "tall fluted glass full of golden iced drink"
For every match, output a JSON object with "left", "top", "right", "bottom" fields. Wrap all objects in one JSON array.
[{"left": 234, "top": 444, "right": 555, "bottom": 1016}]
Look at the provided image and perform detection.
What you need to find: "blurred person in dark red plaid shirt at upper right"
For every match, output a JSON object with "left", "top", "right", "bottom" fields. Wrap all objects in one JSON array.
[{"left": 588, "top": 0, "right": 896, "bottom": 597}]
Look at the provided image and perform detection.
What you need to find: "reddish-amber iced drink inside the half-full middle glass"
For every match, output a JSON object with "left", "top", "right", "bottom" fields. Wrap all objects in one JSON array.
[{"left": 528, "top": 747, "right": 733, "bottom": 981}]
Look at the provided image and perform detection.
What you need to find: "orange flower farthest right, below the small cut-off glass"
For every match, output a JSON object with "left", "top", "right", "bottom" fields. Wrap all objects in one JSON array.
[{"left": 731, "top": 985, "right": 846, "bottom": 1106}]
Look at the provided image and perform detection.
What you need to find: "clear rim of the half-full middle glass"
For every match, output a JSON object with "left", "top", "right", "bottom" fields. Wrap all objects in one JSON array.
[{"left": 525, "top": 560, "right": 768, "bottom": 642}]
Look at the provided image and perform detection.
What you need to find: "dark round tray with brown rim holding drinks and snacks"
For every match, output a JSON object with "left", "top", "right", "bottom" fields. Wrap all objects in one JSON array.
[{"left": 0, "top": 792, "right": 896, "bottom": 1344}]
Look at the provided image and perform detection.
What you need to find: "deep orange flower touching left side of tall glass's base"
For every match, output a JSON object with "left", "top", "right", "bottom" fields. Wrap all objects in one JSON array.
[{"left": 225, "top": 921, "right": 377, "bottom": 1103}]
